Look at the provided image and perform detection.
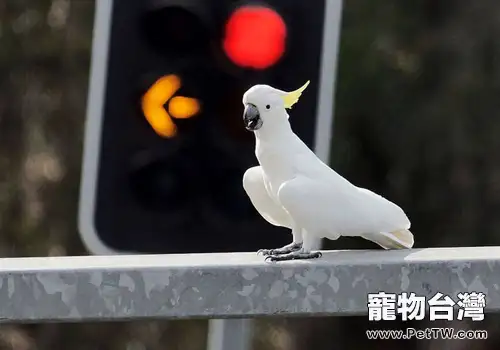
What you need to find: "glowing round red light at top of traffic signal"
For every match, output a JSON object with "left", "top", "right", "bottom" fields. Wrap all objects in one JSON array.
[{"left": 223, "top": 5, "right": 287, "bottom": 69}]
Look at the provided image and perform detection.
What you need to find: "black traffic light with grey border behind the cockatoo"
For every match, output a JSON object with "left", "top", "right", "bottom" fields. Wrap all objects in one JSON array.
[{"left": 79, "top": 0, "right": 337, "bottom": 254}]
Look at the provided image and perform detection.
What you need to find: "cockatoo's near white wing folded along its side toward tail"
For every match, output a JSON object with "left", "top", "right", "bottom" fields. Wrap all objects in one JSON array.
[{"left": 278, "top": 176, "right": 408, "bottom": 239}]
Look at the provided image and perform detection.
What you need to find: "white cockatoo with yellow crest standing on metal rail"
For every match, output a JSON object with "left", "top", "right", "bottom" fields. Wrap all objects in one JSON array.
[{"left": 243, "top": 82, "right": 413, "bottom": 261}]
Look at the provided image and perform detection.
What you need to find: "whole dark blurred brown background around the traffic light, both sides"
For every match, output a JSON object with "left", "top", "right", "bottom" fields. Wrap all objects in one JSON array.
[{"left": 0, "top": 0, "right": 500, "bottom": 350}]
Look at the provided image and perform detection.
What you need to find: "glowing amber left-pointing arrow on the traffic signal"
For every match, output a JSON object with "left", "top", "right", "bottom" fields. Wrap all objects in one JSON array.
[{"left": 141, "top": 74, "right": 200, "bottom": 138}]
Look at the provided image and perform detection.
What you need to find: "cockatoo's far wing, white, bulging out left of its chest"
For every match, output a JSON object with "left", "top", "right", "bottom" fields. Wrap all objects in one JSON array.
[{"left": 243, "top": 166, "right": 292, "bottom": 228}]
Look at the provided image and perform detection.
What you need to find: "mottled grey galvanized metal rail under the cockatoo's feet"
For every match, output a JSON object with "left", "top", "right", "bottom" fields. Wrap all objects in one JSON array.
[{"left": 0, "top": 247, "right": 500, "bottom": 322}]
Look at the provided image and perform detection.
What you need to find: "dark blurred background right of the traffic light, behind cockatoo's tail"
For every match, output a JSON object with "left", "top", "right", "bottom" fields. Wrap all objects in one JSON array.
[{"left": 295, "top": 0, "right": 500, "bottom": 349}]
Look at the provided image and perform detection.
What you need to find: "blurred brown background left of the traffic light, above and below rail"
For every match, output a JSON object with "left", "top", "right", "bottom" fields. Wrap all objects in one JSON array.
[{"left": 0, "top": 0, "right": 206, "bottom": 350}]
